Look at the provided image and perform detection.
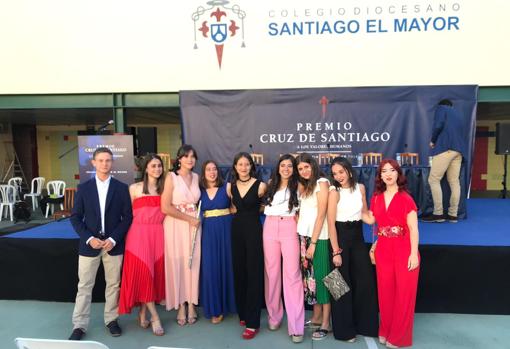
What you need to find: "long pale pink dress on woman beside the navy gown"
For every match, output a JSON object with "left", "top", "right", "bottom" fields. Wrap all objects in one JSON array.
[{"left": 163, "top": 172, "right": 201, "bottom": 310}]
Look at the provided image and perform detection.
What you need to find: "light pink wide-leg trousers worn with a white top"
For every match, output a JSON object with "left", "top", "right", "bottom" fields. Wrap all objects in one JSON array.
[{"left": 263, "top": 216, "right": 305, "bottom": 335}]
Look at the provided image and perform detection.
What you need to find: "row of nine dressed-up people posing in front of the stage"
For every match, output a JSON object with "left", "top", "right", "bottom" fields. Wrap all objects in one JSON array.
[{"left": 66, "top": 145, "right": 420, "bottom": 348}]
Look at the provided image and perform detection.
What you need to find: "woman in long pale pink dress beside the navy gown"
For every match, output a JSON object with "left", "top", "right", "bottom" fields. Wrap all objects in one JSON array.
[{"left": 161, "top": 144, "right": 200, "bottom": 326}]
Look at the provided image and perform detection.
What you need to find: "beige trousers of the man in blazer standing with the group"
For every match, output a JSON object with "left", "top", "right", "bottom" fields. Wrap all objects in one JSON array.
[{"left": 73, "top": 250, "right": 123, "bottom": 331}]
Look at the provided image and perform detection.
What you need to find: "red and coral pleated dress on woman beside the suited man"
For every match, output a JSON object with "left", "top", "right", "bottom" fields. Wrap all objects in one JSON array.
[{"left": 119, "top": 195, "right": 165, "bottom": 314}]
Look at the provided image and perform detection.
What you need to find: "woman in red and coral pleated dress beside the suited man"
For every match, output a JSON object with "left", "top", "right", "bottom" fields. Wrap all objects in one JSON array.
[{"left": 119, "top": 154, "right": 165, "bottom": 336}]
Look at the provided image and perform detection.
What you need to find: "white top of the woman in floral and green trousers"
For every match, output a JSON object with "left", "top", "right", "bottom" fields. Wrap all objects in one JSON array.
[{"left": 298, "top": 178, "right": 329, "bottom": 240}]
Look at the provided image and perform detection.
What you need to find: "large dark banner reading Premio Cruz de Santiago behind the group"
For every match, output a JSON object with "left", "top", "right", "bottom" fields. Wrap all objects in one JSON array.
[{"left": 180, "top": 86, "right": 478, "bottom": 173}]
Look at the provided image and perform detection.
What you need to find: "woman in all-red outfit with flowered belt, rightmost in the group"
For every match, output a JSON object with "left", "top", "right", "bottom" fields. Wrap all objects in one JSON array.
[{"left": 363, "top": 159, "right": 420, "bottom": 348}]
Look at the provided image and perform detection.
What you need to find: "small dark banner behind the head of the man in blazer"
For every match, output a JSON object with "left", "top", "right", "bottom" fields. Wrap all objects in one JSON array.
[{"left": 78, "top": 135, "right": 134, "bottom": 185}]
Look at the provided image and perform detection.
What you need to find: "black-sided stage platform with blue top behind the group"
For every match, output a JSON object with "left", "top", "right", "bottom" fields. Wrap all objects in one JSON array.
[{"left": 0, "top": 199, "right": 510, "bottom": 314}]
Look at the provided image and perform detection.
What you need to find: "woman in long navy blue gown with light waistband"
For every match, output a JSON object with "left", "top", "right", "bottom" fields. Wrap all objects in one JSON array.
[{"left": 200, "top": 160, "right": 236, "bottom": 324}]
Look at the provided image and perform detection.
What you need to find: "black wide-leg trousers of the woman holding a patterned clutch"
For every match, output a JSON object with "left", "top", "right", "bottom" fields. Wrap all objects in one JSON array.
[{"left": 331, "top": 221, "right": 379, "bottom": 340}]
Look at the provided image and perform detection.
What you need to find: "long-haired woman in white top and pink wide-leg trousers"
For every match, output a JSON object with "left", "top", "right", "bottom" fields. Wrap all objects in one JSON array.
[{"left": 263, "top": 154, "right": 305, "bottom": 343}]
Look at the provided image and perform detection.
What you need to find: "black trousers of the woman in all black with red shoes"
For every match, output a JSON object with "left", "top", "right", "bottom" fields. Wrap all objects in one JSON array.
[{"left": 232, "top": 213, "right": 264, "bottom": 328}]
